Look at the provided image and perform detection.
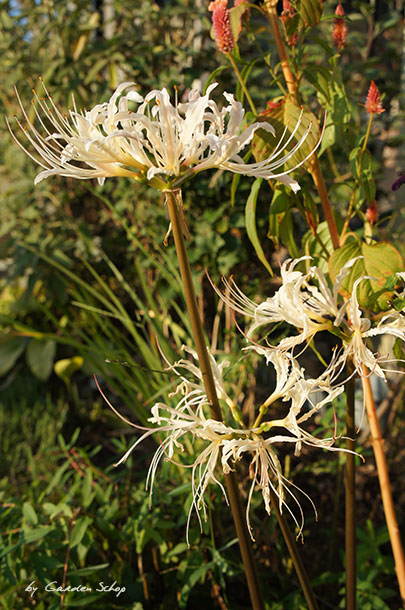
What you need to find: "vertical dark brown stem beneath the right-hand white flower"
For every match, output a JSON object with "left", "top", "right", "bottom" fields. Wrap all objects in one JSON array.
[{"left": 345, "top": 361, "right": 356, "bottom": 610}]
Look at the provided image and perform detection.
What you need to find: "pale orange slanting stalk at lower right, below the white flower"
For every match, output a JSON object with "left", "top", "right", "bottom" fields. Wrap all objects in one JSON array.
[{"left": 362, "top": 365, "right": 405, "bottom": 608}]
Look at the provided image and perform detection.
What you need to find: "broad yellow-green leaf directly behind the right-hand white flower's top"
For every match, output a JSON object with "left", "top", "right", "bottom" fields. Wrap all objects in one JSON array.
[{"left": 329, "top": 240, "right": 403, "bottom": 311}]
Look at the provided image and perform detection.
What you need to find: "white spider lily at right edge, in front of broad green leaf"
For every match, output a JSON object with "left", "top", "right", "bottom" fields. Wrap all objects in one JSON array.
[{"left": 217, "top": 256, "right": 405, "bottom": 379}]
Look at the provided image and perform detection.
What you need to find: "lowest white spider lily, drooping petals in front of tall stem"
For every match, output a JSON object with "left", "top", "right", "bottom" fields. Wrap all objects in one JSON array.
[{"left": 109, "top": 346, "right": 343, "bottom": 541}]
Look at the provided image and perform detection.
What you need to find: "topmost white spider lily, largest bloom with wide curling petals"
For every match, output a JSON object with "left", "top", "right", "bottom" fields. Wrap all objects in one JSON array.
[{"left": 10, "top": 82, "right": 319, "bottom": 191}]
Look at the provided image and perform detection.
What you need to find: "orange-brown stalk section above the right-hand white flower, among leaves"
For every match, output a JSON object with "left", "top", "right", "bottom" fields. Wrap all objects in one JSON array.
[{"left": 264, "top": 0, "right": 340, "bottom": 250}]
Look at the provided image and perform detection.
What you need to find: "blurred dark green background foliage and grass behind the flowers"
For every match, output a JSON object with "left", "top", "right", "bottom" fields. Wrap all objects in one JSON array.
[{"left": 0, "top": 0, "right": 405, "bottom": 610}]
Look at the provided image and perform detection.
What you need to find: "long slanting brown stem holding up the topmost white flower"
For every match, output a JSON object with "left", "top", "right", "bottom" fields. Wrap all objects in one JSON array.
[{"left": 165, "top": 189, "right": 264, "bottom": 610}]
